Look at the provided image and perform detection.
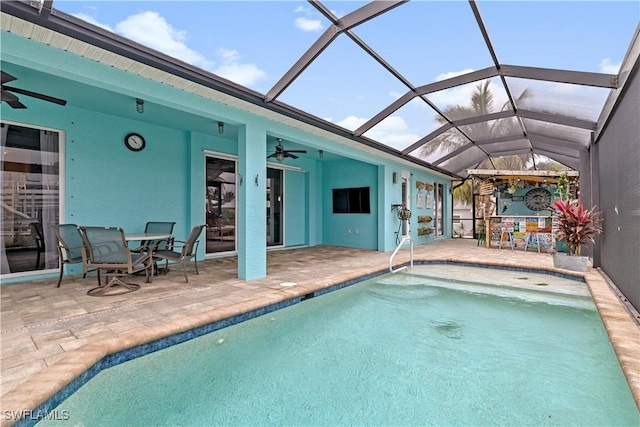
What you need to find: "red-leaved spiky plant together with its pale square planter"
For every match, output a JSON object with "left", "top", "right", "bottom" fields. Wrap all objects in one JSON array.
[{"left": 553, "top": 200, "right": 602, "bottom": 271}]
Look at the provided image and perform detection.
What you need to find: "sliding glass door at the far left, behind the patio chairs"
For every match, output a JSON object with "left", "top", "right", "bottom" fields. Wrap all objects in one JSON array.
[{"left": 0, "top": 123, "right": 60, "bottom": 275}]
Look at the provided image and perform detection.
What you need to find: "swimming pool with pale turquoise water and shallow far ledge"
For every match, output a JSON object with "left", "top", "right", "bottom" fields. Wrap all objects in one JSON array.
[{"left": 40, "top": 265, "right": 639, "bottom": 426}]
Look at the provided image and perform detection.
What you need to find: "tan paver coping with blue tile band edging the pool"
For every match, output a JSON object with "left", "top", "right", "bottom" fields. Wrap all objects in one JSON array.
[{"left": 2, "top": 258, "right": 640, "bottom": 426}]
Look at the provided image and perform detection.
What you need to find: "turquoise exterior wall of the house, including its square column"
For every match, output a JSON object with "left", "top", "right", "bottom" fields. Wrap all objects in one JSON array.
[{"left": 1, "top": 32, "right": 451, "bottom": 283}]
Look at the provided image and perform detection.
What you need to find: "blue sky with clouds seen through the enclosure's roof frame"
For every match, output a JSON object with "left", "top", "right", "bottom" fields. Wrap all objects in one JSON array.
[{"left": 53, "top": 0, "right": 640, "bottom": 152}]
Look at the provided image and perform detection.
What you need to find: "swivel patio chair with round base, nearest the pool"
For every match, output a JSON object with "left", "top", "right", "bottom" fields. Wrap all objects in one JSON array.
[{"left": 80, "top": 227, "right": 153, "bottom": 296}]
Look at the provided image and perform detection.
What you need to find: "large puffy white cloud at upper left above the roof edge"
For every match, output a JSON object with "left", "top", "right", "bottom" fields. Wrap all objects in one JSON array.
[{"left": 116, "top": 11, "right": 213, "bottom": 69}]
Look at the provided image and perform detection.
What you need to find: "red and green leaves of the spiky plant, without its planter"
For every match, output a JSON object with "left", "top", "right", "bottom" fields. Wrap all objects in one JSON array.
[{"left": 554, "top": 200, "right": 602, "bottom": 256}]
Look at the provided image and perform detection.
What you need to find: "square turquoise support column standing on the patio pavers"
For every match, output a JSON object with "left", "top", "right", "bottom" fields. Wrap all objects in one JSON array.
[{"left": 236, "top": 125, "right": 267, "bottom": 280}]
